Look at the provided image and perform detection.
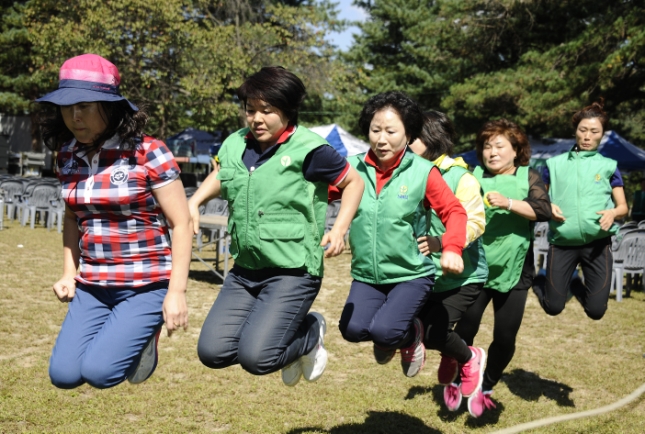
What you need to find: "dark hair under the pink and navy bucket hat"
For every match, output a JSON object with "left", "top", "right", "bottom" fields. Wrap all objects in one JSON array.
[{"left": 39, "top": 100, "right": 148, "bottom": 151}]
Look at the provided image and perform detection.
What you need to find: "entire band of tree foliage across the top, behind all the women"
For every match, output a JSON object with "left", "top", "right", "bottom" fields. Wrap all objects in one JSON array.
[{"left": 0, "top": 0, "right": 645, "bottom": 158}]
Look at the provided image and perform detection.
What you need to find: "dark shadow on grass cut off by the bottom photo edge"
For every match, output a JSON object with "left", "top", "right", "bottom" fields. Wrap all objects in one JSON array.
[{"left": 288, "top": 411, "right": 441, "bottom": 434}]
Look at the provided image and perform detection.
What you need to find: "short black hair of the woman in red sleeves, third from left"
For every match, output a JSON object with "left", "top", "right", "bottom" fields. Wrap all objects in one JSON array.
[{"left": 358, "top": 90, "right": 423, "bottom": 143}]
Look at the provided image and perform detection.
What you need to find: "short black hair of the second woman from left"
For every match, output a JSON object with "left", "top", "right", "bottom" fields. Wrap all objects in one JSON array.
[{"left": 237, "top": 66, "right": 307, "bottom": 125}]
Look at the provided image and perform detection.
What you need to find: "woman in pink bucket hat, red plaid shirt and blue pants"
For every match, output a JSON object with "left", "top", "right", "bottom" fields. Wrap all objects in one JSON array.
[{"left": 36, "top": 54, "right": 192, "bottom": 389}]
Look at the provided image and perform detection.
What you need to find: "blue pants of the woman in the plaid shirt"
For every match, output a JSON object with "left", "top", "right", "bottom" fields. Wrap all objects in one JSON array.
[{"left": 49, "top": 282, "right": 168, "bottom": 389}]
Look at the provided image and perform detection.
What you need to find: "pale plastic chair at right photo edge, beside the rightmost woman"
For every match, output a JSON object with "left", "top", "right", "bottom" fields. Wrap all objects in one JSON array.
[{"left": 611, "top": 229, "right": 645, "bottom": 301}]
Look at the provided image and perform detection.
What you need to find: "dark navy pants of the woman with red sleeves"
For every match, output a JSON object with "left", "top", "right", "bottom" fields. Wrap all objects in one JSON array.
[{"left": 338, "top": 277, "right": 434, "bottom": 349}]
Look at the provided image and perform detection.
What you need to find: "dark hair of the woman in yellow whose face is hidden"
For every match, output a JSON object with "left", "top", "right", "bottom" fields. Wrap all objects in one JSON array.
[{"left": 419, "top": 110, "right": 457, "bottom": 161}]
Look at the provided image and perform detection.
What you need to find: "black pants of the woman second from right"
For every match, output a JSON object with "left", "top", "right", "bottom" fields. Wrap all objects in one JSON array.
[{"left": 455, "top": 287, "right": 528, "bottom": 390}]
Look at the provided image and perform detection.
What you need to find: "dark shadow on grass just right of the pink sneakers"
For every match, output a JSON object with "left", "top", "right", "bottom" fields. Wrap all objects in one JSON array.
[{"left": 502, "top": 369, "right": 575, "bottom": 407}]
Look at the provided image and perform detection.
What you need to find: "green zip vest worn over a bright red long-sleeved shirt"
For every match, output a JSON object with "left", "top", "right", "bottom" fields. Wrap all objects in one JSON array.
[{"left": 348, "top": 151, "right": 435, "bottom": 285}]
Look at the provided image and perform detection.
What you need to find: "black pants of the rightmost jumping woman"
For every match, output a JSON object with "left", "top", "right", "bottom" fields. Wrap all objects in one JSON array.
[{"left": 534, "top": 238, "right": 613, "bottom": 320}]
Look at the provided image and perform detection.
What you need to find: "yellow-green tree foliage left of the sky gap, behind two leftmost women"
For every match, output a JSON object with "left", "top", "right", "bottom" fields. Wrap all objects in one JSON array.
[{"left": 0, "top": 0, "right": 344, "bottom": 137}]
